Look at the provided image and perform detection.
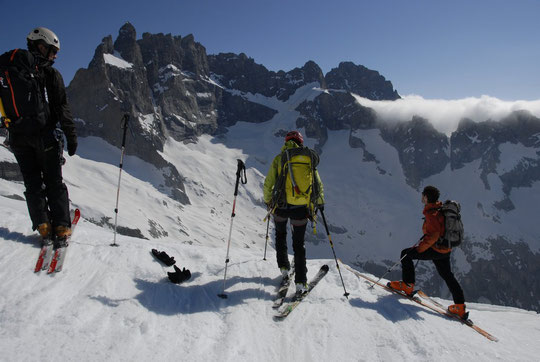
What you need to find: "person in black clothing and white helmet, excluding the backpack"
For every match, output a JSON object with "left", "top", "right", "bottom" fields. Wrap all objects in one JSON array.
[{"left": 9, "top": 27, "right": 77, "bottom": 244}]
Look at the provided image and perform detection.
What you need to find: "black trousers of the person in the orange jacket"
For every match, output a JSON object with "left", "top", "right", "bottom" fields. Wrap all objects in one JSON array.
[{"left": 401, "top": 248, "right": 465, "bottom": 304}]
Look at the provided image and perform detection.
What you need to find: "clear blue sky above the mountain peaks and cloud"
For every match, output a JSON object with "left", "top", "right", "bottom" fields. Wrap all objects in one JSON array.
[{"left": 0, "top": 0, "right": 540, "bottom": 100}]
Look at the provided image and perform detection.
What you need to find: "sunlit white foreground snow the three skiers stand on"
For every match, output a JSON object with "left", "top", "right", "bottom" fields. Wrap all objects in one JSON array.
[{"left": 0, "top": 191, "right": 540, "bottom": 361}]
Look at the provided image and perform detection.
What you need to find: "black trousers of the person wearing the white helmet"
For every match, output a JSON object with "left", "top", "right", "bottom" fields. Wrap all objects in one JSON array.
[{"left": 10, "top": 131, "right": 71, "bottom": 230}]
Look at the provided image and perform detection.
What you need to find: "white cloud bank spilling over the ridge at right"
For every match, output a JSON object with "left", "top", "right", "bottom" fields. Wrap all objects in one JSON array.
[{"left": 355, "top": 95, "right": 540, "bottom": 135}]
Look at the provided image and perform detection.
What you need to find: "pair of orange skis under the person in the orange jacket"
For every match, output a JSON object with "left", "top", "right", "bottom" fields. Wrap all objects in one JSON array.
[{"left": 344, "top": 264, "right": 499, "bottom": 342}]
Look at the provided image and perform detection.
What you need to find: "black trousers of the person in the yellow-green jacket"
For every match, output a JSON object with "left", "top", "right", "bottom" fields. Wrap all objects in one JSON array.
[{"left": 274, "top": 206, "right": 308, "bottom": 283}]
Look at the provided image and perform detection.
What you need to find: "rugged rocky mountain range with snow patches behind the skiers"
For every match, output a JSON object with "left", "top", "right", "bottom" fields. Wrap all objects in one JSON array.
[{"left": 0, "top": 24, "right": 540, "bottom": 311}]
